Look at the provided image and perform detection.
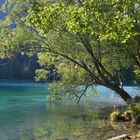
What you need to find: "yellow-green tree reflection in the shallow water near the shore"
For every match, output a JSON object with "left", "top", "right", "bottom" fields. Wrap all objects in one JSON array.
[{"left": 10, "top": 102, "right": 140, "bottom": 140}]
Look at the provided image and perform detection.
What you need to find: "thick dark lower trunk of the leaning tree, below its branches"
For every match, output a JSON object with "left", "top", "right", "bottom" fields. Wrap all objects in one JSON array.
[{"left": 106, "top": 84, "right": 133, "bottom": 104}]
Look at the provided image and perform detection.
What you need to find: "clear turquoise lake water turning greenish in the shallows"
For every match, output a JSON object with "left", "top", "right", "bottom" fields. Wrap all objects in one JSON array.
[{"left": 0, "top": 81, "right": 140, "bottom": 140}]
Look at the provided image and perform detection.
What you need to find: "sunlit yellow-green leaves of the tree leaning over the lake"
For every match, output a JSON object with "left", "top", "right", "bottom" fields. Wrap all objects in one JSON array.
[{"left": 27, "top": 0, "right": 139, "bottom": 98}]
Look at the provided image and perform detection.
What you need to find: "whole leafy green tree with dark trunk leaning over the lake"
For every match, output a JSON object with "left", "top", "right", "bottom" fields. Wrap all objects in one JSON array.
[{"left": 1, "top": 0, "right": 139, "bottom": 102}]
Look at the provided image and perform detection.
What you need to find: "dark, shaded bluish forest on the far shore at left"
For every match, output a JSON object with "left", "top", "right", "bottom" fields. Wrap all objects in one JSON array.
[{"left": 0, "top": 55, "right": 39, "bottom": 80}]
